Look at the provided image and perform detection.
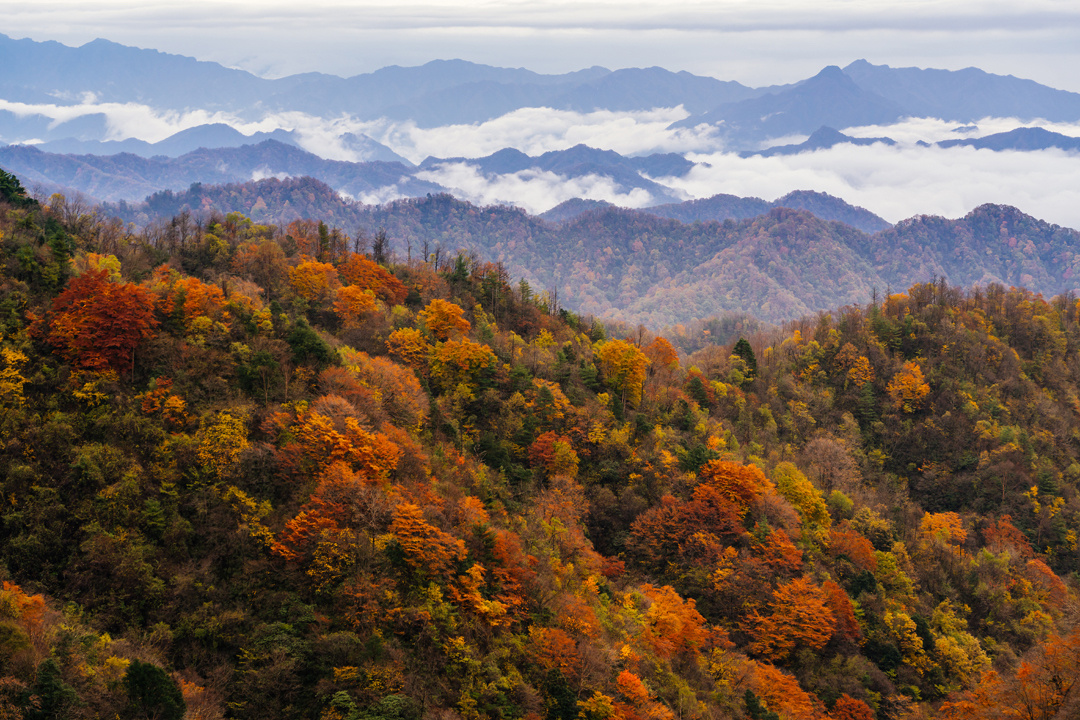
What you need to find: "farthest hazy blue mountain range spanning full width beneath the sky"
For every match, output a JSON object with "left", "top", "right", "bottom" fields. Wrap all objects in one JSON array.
[{"left": 0, "top": 35, "right": 1080, "bottom": 154}]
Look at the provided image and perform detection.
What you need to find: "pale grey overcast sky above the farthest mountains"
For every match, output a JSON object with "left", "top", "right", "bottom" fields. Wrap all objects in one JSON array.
[{"left": 6, "top": 0, "right": 1080, "bottom": 92}]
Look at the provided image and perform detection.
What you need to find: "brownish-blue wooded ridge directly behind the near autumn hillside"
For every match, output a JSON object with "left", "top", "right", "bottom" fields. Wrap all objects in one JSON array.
[{"left": 90, "top": 172, "right": 1080, "bottom": 327}]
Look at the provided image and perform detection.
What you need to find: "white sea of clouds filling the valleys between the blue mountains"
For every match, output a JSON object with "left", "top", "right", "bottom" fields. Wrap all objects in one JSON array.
[{"left": 0, "top": 96, "right": 1080, "bottom": 228}]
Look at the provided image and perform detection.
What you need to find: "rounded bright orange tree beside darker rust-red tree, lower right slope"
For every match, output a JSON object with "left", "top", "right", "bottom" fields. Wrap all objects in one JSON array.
[{"left": 747, "top": 578, "right": 836, "bottom": 660}]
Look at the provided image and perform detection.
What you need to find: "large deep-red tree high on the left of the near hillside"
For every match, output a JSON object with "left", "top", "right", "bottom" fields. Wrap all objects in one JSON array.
[{"left": 44, "top": 270, "right": 158, "bottom": 371}]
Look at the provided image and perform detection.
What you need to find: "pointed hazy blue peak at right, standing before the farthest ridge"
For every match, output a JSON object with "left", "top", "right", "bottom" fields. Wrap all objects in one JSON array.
[{"left": 674, "top": 65, "right": 907, "bottom": 149}]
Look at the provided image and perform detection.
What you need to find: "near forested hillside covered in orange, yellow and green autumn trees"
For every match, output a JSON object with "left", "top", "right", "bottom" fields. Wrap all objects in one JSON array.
[{"left": 0, "top": 165, "right": 1080, "bottom": 720}]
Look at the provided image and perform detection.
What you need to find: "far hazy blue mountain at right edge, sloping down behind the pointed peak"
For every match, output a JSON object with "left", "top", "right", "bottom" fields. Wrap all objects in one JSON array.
[{"left": 838, "top": 59, "right": 1080, "bottom": 121}]
